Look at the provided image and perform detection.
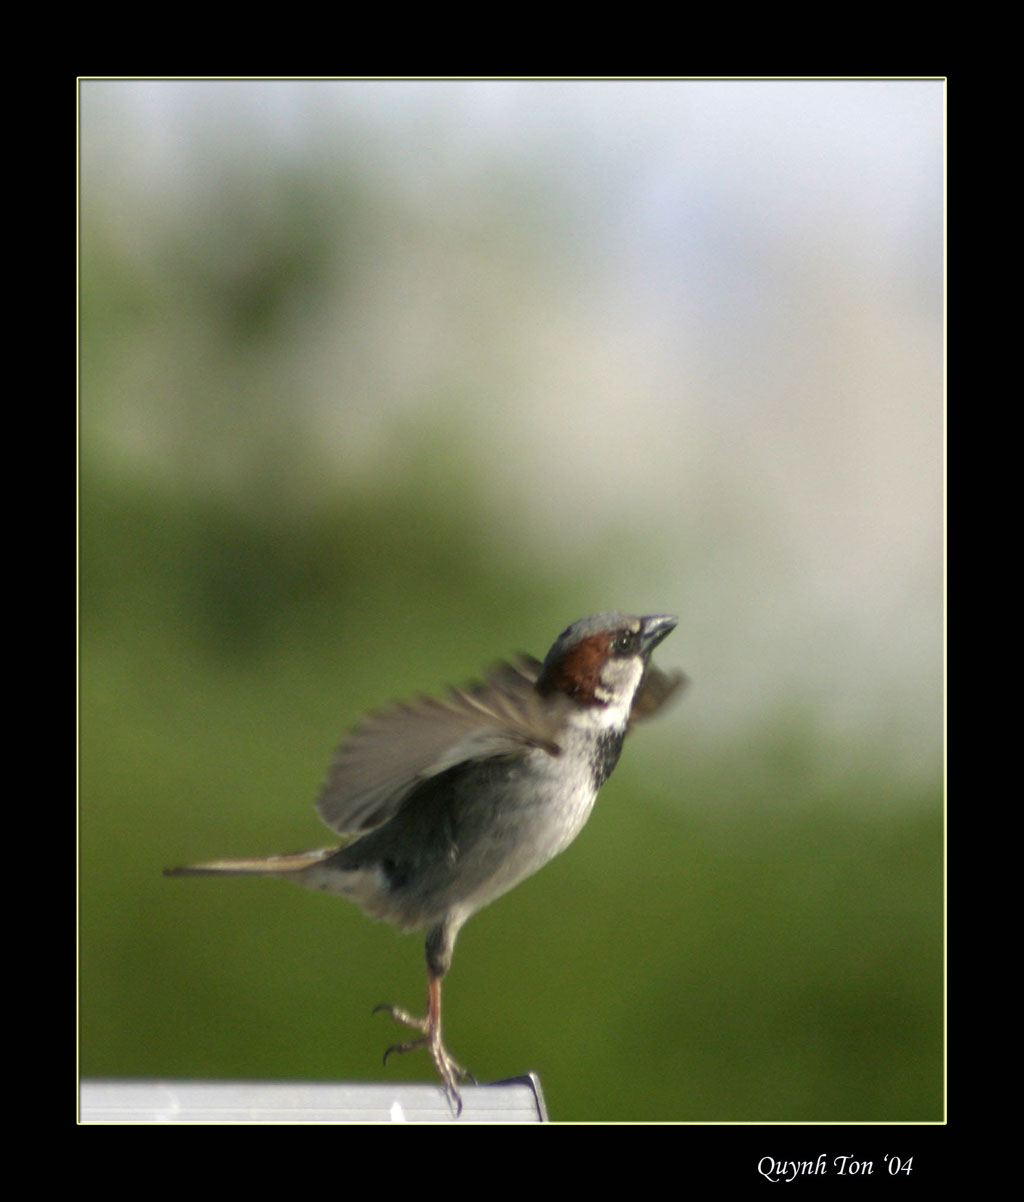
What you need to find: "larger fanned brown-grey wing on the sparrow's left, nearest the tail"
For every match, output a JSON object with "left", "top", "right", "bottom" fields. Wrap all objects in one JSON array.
[{"left": 316, "top": 660, "right": 564, "bottom": 834}]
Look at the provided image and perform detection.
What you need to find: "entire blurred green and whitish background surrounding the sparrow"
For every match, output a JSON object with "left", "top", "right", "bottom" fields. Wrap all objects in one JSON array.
[{"left": 78, "top": 81, "right": 943, "bottom": 1121}]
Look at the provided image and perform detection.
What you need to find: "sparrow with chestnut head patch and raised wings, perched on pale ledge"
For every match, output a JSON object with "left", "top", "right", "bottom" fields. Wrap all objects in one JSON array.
[{"left": 165, "top": 612, "right": 685, "bottom": 1117}]
